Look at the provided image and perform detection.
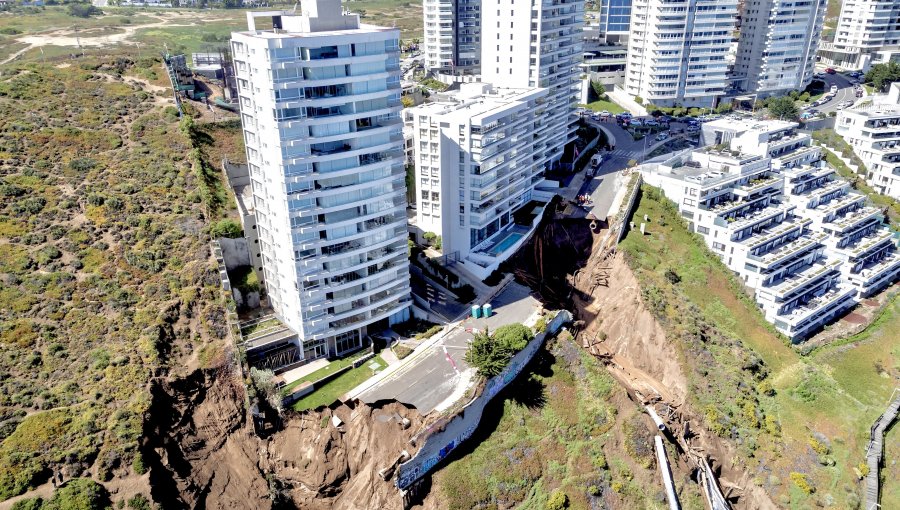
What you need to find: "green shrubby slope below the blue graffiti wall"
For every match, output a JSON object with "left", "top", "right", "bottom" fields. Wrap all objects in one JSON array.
[{"left": 433, "top": 336, "right": 688, "bottom": 510}]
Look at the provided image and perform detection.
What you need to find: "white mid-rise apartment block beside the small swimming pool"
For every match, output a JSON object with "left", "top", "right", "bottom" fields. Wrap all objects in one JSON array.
[{"left": 410, "top": 83, "right": 556, "bottom": 277}]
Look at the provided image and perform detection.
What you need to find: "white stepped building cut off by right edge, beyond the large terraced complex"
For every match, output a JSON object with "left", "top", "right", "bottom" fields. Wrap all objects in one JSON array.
[{"left": 834, "top": 83, "right": 900, "bottom": 200}]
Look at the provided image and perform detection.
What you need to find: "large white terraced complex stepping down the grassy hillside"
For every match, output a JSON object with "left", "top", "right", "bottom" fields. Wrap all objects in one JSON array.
[{"left": 642, "top": 120, "right": 900, "bottom": 341}]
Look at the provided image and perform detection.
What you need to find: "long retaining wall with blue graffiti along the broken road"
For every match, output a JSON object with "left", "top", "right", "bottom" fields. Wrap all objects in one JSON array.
[{"left": 396, "top": 310, "right": 572, "bottom": 490}]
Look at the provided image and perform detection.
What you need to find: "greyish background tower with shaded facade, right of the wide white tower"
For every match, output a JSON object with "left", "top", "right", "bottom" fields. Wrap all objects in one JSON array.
[{"left": 734, "top": 0, "right": 826, "bottom": 96}]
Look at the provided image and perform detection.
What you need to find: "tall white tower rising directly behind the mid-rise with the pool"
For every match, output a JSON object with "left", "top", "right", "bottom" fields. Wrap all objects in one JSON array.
[{"left": 481, "top": 0, "right": 584, "bottom": 155}]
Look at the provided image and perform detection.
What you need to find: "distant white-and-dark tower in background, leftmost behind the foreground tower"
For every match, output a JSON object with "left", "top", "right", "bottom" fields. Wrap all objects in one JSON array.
[{"left": 422, "top": 0, "right": 481, "bottom": 83}]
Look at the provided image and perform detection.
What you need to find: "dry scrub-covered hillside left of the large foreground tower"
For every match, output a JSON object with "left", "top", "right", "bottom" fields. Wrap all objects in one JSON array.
[{"left": 0, "top": 57, "right": 236, "bottom": 501}]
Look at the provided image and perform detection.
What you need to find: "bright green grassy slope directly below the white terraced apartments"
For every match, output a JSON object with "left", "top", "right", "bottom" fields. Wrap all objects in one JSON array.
[{"left": 620, "top": 186, "right": 900, "bottom": 508}]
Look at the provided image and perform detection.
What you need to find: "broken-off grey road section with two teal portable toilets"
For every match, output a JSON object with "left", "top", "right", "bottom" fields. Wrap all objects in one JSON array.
[{"left": 359, "top": 282, "right": 540, "bottom": 414}]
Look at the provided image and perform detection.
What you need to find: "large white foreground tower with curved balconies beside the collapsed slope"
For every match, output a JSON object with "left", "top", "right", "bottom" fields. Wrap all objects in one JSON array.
[{"left": 232, "top": 4, "right": 410, "bottom": 359}]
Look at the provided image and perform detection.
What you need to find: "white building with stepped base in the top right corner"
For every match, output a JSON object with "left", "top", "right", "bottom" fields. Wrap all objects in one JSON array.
[{"left": 819, "top": 0, "right": 900, "bottom": 70}]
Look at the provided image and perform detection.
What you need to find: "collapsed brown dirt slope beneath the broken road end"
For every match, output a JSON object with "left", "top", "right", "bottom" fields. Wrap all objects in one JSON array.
[{"left": 144, "top": 370, "right": 420, "bottom": 510}]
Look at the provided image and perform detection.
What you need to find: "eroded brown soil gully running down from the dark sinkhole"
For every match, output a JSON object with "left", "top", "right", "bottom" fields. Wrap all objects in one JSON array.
[{"left": 512, "top": 208, "right": 776, "bottom": 509}]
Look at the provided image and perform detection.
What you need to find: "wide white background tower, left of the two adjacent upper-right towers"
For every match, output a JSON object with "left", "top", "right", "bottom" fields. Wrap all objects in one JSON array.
[{"left": 625, "top": 0, "right": 738, "bottom": 108}]
